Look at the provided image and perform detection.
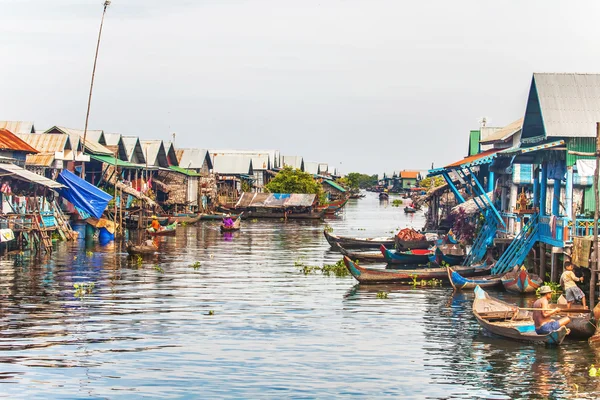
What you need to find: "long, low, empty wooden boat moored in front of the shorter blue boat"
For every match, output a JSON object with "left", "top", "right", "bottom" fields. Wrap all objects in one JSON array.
[{"left": 344, "top": 256, "right": 489, "bottom": 284}]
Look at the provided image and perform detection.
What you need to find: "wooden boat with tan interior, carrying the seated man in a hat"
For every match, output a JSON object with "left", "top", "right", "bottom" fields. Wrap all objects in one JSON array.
[{"left": 473, "top": 287, "right": 567, "bottom": 345}]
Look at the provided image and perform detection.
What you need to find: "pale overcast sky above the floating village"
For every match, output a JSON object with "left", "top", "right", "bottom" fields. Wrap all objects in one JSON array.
[{"left": 0, "top": 0, "right": 600, "bottom": 173}]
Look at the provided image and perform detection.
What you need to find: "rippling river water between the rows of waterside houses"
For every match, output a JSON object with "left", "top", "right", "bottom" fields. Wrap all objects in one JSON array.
[{"left": 0, "top": 193, "right": 600, "bottom": 399}]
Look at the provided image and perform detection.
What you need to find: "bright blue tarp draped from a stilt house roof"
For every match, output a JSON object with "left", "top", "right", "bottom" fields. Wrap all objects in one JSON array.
[{"left": 56, "top": 170, "right": 112, "bottom": 218}]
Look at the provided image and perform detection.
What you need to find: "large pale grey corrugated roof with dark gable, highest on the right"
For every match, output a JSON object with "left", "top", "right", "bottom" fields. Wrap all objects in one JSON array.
[{"left": 523, "top": 73, "right": 600, "bottom": 138}]
